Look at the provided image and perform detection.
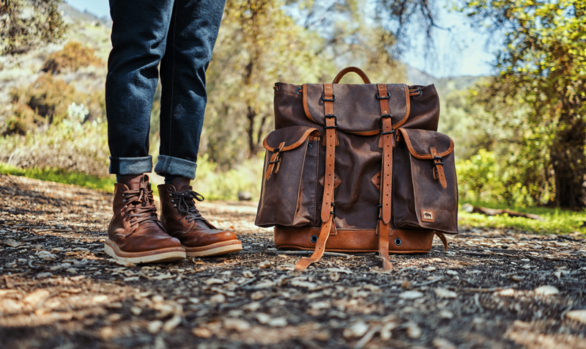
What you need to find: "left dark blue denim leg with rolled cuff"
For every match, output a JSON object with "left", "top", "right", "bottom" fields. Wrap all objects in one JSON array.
[{"left": 106, "top": 0, "right": 174, "bottom": 174}]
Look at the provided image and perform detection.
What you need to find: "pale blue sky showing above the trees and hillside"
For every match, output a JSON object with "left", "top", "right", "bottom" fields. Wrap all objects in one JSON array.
[{"left": 66, "top": 0, "right": 494, "bottom": 78}]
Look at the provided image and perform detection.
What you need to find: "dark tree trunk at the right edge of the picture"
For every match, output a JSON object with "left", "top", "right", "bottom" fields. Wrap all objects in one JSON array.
[{"left": 550, "top": 117, "right": 586, "bottom": 209}]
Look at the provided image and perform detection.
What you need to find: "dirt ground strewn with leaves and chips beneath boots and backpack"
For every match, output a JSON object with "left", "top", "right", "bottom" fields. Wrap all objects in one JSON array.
[{"left": 0, "top": 176, "right": 586, "bottom": 348}]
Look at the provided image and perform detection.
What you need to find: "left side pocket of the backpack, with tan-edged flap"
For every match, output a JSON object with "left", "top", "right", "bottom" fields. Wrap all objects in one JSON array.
[{"left": 255, "top": 126, "right": 320, "bottom": 227}]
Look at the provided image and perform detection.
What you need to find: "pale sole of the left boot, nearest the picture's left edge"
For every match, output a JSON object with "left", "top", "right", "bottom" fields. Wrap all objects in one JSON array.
[{"left": 104, "top": 239, "right": 187, "bottom": 265}]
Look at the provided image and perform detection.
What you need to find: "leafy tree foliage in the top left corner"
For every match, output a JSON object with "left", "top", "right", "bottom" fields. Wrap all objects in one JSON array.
[{"left": 0, "top": 0, "right": 66, "bottom": 54}]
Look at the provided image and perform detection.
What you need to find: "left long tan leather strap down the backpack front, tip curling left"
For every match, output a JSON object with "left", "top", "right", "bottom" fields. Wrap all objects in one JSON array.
[{"left": 295, "top": 84, "right": 336, "bottom": 271}]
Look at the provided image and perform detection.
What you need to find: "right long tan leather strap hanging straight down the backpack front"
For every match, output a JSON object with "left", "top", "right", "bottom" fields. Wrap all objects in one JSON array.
[{"left": 377, "top": 84, "right": 395, "bottom": 271}]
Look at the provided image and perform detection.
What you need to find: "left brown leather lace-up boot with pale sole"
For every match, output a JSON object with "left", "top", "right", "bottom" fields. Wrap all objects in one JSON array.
[{"left": 104, "top": 175, "right": 186, "bottom": 265}]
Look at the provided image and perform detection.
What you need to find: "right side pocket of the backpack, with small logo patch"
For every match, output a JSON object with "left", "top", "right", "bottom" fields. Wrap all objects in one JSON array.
[{"left": 393, "top": 128, "right": 458, "bottom": 234}]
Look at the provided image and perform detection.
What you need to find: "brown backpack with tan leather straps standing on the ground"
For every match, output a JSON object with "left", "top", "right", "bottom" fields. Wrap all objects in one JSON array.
[{"left": 255, "top": 67, "right": 458, "bottom": 270}]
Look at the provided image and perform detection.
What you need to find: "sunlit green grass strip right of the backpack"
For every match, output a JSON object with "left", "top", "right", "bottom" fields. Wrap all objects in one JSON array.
[{"left": 458, "top": 202, "right": 586, "bottom": 234}]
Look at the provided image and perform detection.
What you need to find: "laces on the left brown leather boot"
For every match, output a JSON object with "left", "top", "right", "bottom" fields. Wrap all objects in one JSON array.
[{"left": 122, "top": 184, "right": 158, "bottom": 227}]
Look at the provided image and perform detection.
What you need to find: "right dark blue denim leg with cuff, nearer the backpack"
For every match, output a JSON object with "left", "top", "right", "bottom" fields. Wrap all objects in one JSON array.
[{"left": 155, "top": 0, "right": 224, "bottom": 178}]
